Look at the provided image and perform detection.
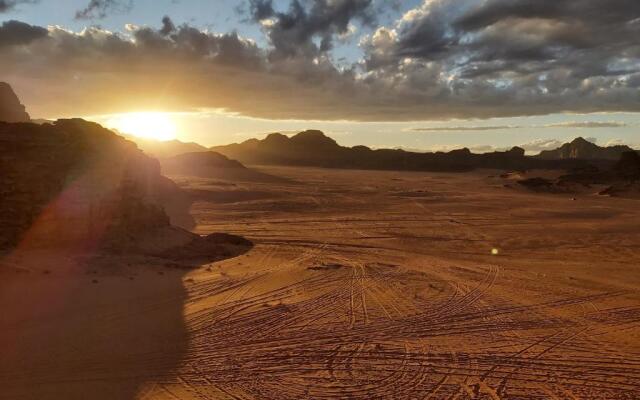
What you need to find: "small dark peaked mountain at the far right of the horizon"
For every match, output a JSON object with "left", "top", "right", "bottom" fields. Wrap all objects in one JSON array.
[{"left": 535, "top": 137, "right": 634, "bottom": 161}]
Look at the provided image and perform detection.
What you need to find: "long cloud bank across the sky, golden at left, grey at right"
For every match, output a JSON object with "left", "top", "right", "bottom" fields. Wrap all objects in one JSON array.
[{"left": 0, "top": 0, "right": 640, "bottom": 122}]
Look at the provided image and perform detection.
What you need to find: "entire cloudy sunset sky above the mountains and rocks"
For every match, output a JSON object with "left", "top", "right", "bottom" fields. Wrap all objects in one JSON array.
[{"left": 0, "top": 0, "right": 640, "bottom": 153}]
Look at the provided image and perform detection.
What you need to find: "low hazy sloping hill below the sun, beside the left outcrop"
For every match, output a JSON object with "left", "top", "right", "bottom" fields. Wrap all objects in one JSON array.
[{"left": 160, "top": 151, "right": 284, "bottom": 182}]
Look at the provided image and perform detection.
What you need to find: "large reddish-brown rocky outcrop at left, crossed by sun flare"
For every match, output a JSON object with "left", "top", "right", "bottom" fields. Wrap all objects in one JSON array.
[{"left": 0, "top": 119, "right": 188, "bottom": 250}]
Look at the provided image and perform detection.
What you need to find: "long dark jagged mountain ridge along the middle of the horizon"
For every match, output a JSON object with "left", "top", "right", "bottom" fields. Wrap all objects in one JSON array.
[{"left": 212, "top": 130, "right": 580, "bottom": 171}]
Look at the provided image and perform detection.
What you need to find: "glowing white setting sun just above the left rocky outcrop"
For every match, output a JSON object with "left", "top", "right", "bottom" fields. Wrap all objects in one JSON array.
[{"left": 107, "top": 112, "right": 177, "bottom": 141}]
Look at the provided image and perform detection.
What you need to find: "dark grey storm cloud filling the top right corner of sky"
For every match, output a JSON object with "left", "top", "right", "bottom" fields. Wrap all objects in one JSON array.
[{"left": 364, "top": 0, "right": 640, "bottom": 70}]
